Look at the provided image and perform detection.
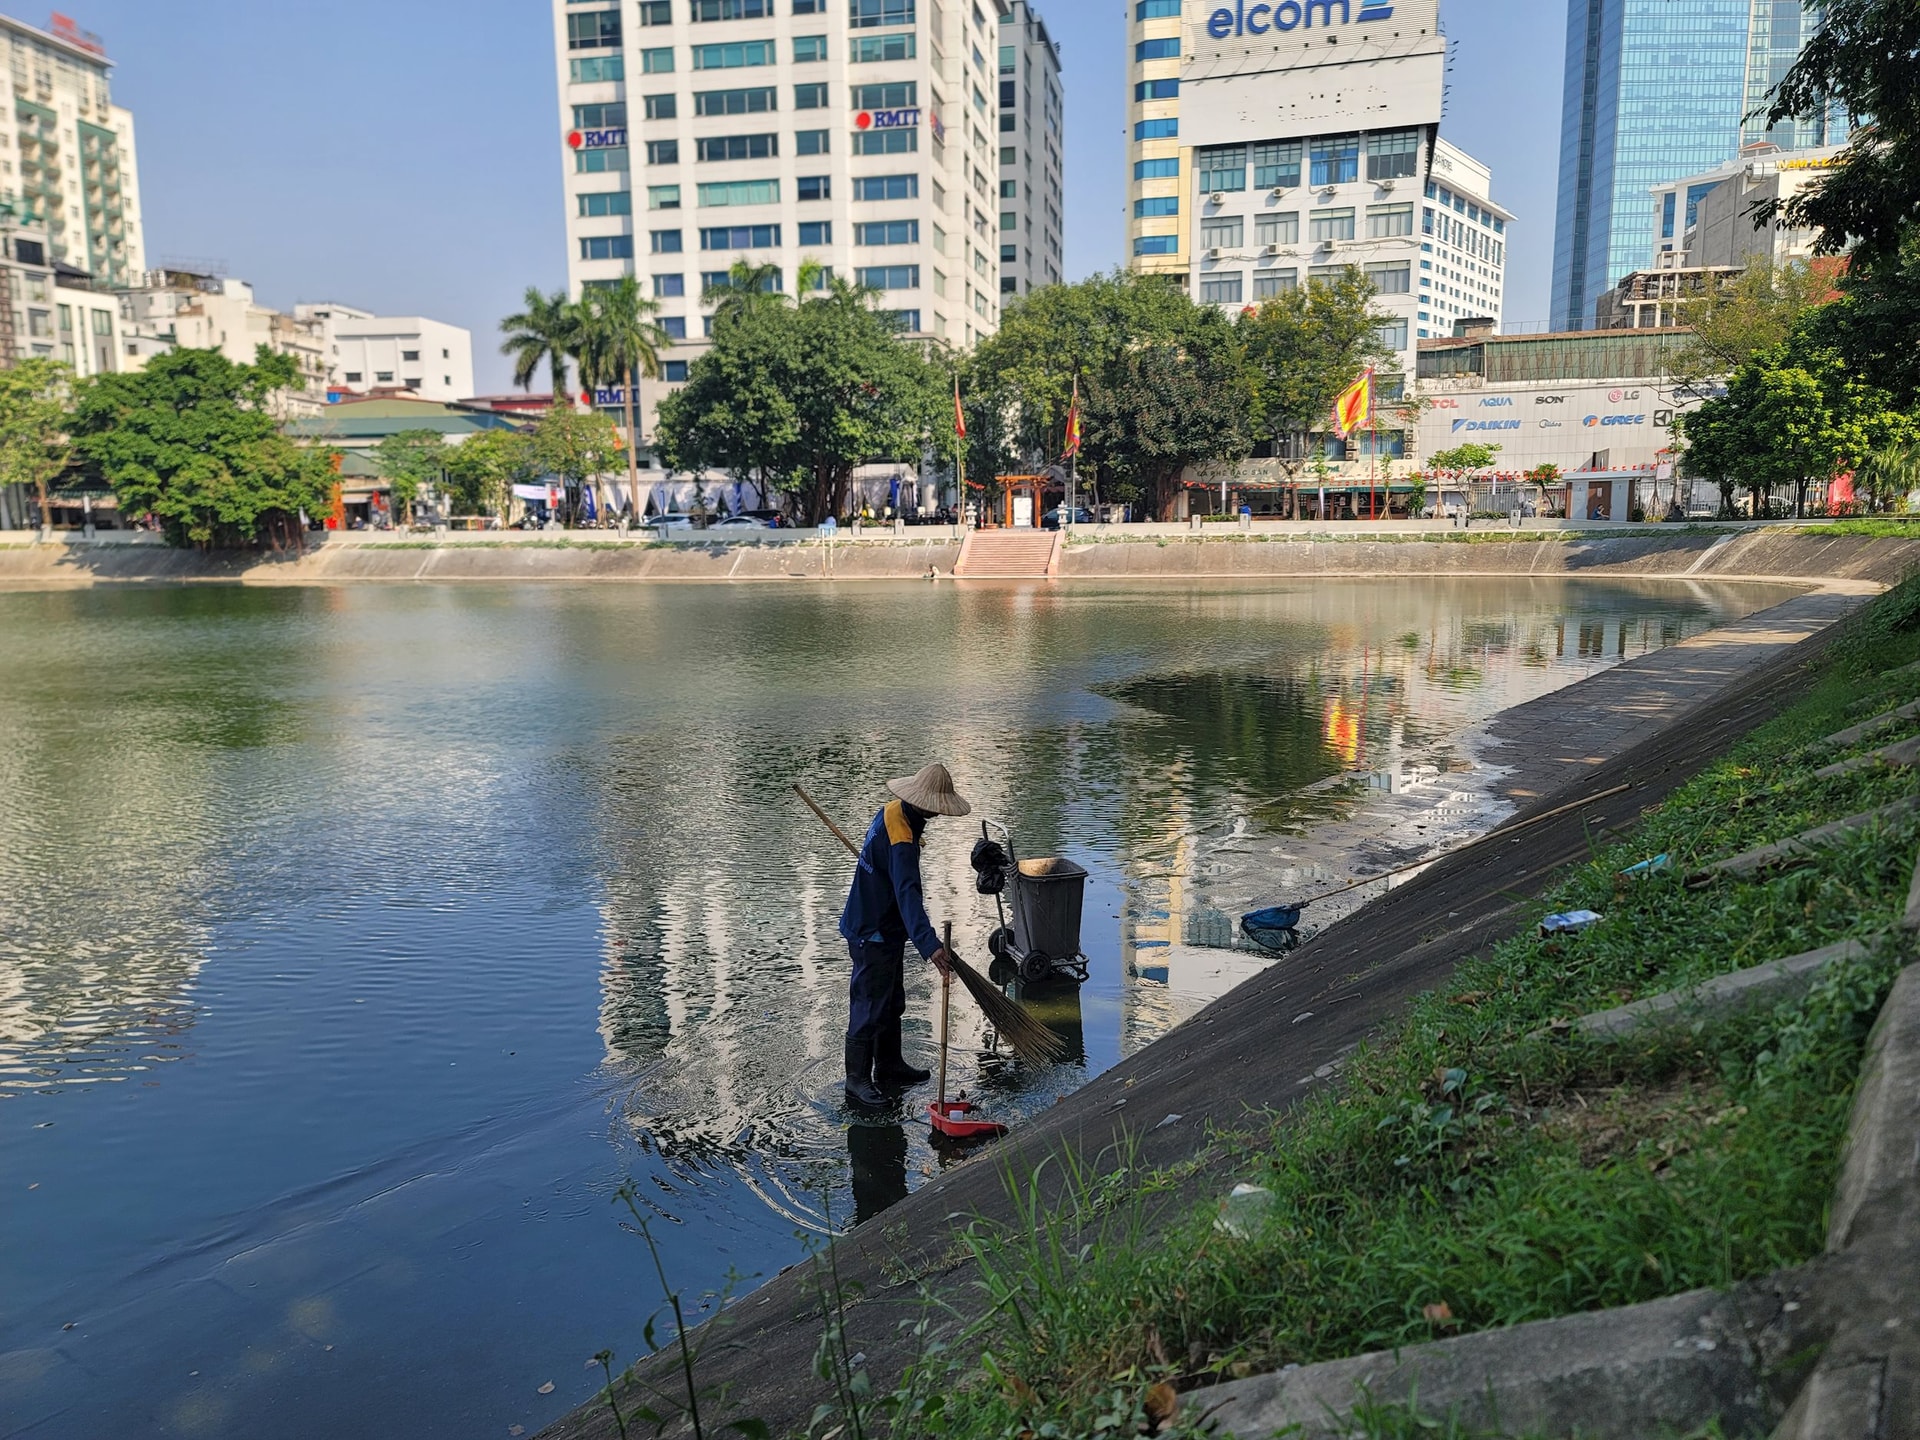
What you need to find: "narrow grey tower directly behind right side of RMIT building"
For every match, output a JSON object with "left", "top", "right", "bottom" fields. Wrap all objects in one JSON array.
[{"left": 1000, "top": 0, "right": 1066, "bottom": 296}]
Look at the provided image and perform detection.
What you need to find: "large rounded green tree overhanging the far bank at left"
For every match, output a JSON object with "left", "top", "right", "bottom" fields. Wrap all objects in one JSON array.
[{"left": 73, "top": 346, "right": 332, "bottom": 549}]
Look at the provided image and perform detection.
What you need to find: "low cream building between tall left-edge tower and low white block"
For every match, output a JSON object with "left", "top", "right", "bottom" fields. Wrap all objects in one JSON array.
[{"left": 119, "top": 271, "right": 326, "bottom": 417}]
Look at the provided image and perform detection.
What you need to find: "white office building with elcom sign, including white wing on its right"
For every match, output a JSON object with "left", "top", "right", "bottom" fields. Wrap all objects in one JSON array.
[{"left": 1175, "top": 0, "right": 1511, "bottom": 380}]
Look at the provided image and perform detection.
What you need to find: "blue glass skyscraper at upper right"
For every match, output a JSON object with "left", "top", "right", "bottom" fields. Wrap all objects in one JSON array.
[{"left": 1551, "top": 0, "right": 1847, "bottom": 330}]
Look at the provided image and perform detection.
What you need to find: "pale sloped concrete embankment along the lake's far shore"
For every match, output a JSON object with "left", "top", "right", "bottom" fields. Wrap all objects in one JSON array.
[{"left": 11, "top": 524, "right": 1920, "bottom": 588}]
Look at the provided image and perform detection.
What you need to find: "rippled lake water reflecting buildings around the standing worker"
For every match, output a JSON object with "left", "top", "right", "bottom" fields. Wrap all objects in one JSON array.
[{"left": 0, "top": 580, "right": 1776, "bottom": 1440}]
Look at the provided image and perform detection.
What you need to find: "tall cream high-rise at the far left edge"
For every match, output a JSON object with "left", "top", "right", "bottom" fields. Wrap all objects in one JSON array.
[{"left": 0, "top": 15, "right": 146, "bottom": 374}]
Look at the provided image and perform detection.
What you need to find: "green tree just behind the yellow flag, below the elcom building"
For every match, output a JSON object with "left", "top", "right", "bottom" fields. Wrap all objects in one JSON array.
[{"left": 1236, "top": 265, "right": 1394, "bottom": 468}]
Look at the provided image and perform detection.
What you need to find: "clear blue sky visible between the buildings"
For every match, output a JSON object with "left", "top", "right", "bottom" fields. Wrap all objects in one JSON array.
[{"left": 45, "top": 0, "right": 1567, "bottom": 390}]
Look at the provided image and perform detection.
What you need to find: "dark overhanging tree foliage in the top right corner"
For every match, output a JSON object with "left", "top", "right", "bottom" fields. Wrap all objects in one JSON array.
[{"left": 1761, "top": 0, "right": 1920, "bottom": 271}]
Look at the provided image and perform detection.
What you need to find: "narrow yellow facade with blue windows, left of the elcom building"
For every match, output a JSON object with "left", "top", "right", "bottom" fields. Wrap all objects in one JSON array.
[{"left": 1127, "top": 0, "right": 1202, "bottom": 275}]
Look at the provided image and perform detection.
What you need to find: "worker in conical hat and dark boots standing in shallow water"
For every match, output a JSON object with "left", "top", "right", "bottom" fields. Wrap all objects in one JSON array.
[{"left": 841, "top": 764, "right": 973, "bottom": 1108}]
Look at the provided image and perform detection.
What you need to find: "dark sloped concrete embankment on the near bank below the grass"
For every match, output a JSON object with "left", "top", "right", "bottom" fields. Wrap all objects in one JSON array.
[{"left": 543, "top": 579, "right": 1891, "bottom": 1440}]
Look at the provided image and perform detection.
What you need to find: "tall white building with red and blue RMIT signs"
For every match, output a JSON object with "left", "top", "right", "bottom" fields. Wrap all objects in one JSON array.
[{"left": 553, "top": 0, "right": 1006, "bottom": 449}]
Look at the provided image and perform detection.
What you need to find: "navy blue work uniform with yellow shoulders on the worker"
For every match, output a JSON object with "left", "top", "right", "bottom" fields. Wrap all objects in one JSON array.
[{"left": 841, "top": 801, "right": 941, "bottom": 1041}]
